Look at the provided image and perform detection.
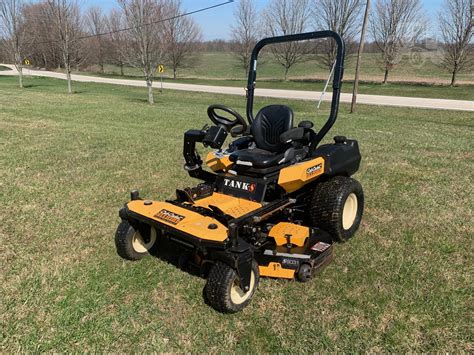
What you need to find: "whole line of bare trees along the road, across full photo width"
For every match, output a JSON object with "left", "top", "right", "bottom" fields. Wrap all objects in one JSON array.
[{"left": 0, "top": 0, "right": 473, "bottom": 103}]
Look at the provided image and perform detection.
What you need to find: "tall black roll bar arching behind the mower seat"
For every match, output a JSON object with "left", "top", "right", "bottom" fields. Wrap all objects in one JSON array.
[{"left": 247, "top": 31, "right": 345, "bottom": 152}]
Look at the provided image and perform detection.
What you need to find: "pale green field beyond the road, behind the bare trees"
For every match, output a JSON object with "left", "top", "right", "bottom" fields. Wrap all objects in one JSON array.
[{"left": 87, "top": 52, "right": 474, "bottom": 84}]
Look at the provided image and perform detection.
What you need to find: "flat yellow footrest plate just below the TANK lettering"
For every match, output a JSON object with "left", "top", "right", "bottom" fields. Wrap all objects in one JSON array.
[{"left": 194, "top": 192, "right": 262, "bottom": 218}]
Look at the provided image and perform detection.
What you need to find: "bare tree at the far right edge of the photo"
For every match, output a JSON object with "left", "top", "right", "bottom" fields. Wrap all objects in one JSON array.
[{"left": 438, "top": 0, "right": 474, "bottom": 86}]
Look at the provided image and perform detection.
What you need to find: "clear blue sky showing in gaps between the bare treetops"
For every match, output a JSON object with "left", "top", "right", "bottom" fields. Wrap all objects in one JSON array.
[{"left": 79, "top": 0, "right": 443, "bottom": 40}]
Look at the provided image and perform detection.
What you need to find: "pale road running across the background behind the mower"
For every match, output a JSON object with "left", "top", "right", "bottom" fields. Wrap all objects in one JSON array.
[{"left": 0, "top": 64, "right": 474, "bottom": 111}]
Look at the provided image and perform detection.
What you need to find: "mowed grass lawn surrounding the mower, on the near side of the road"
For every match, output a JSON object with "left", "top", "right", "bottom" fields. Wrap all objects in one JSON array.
[{"left": 0, "top": 77, "right": 474, "bottom": 353}]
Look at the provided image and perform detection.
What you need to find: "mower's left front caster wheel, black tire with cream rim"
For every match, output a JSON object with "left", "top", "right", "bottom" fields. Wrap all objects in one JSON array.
[{"left": 115, "top": 220, "right": 156, "bottom": 261}]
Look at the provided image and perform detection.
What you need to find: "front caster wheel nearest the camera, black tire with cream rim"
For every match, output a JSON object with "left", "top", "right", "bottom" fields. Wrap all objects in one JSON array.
[{"left": 204, "top": 261, "right": 260, "bottom": 313}]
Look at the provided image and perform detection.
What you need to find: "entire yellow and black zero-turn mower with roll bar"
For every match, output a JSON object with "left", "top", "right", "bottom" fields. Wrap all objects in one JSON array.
[{"left": 115, "top": 31, "right": 364, "bottom": 312}]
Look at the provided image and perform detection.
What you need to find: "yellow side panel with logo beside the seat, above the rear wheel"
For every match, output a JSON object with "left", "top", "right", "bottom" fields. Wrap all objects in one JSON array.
[{"left": 278, "top": 157, "right": 324, "bottom": 193}]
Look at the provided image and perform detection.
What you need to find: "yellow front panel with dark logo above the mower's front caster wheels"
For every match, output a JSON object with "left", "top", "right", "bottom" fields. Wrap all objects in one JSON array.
[{"left": 127, "top": 200, "right": 227, "bottom": 242}]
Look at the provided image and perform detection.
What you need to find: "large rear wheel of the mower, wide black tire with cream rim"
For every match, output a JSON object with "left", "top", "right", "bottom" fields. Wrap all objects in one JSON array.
[{"left": 309, "top": 176, "right": 364, "bottom": 242}]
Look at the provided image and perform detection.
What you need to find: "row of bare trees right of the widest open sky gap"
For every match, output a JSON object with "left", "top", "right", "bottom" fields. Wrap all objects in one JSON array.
[{"left": 232, "top": 0, "right": 474, "bottom": 86}]
